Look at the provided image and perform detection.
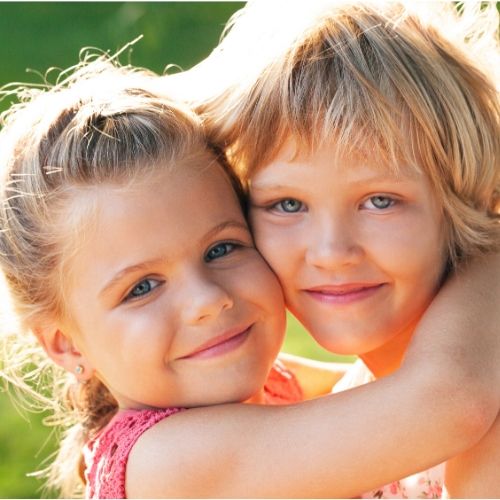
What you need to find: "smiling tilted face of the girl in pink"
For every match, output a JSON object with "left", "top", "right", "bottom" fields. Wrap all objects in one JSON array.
[{"left": 60, "top": 165, "right": 285, "bottom": 408}]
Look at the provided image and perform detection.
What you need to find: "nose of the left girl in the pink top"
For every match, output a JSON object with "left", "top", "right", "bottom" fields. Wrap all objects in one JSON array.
[{"left": 181, "top": 275, "right": 234, "bottom": 325}]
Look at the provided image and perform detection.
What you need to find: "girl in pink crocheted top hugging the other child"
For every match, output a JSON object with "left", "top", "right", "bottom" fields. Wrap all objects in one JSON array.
[{"left": 0, "top": 61, "right": 499, "bottom": 498}]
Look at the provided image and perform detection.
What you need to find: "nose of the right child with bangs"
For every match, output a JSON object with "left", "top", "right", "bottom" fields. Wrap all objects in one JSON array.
[{"left": 305, "top": 214, "right": 363, "bottom": 270}]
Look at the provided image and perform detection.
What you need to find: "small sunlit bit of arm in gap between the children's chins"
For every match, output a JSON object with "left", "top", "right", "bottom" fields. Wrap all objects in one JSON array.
[{"left": 279, "top": 352, "right": 351, "bottom": 399}]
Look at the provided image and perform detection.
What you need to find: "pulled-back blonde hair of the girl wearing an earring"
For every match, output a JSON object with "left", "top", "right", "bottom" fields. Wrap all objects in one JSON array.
[{"left": 0, "top": 57, "right": 238, "bottom": 497}]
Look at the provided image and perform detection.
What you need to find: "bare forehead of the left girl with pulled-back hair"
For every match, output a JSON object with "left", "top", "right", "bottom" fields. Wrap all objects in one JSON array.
[{"left": 61, "top": 163, "right": 245, "bottom": 283}]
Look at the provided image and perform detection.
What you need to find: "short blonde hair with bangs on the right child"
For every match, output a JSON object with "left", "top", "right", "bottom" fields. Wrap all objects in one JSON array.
[{"left": 187, "top": 0, "right": 500, "bottom": 264}]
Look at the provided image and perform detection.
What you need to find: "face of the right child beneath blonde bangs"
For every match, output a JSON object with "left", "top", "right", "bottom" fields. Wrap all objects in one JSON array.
[{"left": 250, "top": 143, "right": 445, "bottom": 354}]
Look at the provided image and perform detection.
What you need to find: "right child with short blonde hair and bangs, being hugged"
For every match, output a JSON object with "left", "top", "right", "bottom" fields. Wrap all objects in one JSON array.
[{"left": 175, "top": 1, "right": 500, "bottom": 497}]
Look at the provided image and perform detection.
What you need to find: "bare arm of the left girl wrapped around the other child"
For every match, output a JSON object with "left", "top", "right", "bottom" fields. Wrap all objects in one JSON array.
[{"left": 126, "top": 256, "right": 500, "bottom": 498}]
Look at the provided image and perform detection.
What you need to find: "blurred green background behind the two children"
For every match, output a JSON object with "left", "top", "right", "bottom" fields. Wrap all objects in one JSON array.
[{"left": 0, "top": 2, "right": 352, "bottom": 498}]
